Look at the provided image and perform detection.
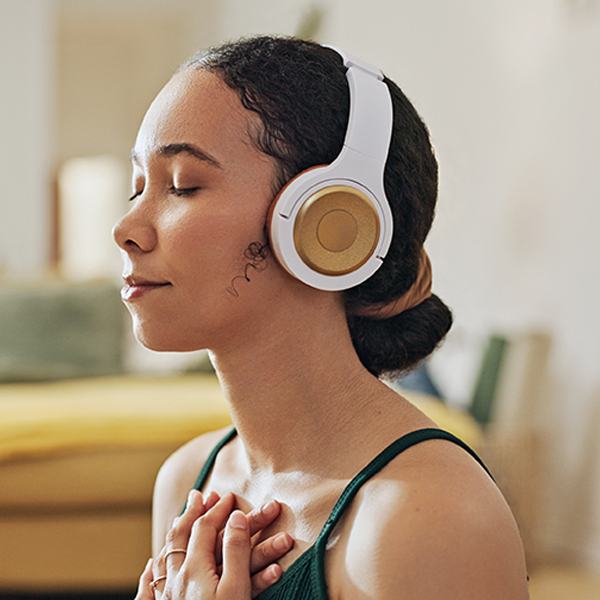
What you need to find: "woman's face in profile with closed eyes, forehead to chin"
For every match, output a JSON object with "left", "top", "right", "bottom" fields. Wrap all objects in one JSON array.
[{"left": 113, "top": 69, "right": 290, "bottom": 351}]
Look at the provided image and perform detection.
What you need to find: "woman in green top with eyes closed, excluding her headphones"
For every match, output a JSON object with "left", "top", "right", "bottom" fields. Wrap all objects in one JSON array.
[{"left": 114, "top": 37, "right": 528, "bottom": 600}]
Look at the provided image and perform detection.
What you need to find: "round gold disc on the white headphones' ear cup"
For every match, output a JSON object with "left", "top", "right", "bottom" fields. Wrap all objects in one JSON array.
[{"left": 294, "top": 185, "right": 379, "bottom": 275}]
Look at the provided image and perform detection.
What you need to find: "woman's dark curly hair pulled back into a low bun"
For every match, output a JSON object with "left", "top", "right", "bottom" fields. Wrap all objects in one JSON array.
[{"left": 182, "top": 36, "right": 452, "bottom": 376}]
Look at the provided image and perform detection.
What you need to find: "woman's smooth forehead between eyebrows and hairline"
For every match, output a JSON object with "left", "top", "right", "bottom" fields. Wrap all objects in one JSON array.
[{"left": 134, "top": 68, "right": 260, "bottom": 164}]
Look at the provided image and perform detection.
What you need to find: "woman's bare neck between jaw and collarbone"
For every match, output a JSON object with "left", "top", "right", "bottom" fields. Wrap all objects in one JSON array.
[{"left": 212, "top": 298, "right": 387, "bottom": 472}]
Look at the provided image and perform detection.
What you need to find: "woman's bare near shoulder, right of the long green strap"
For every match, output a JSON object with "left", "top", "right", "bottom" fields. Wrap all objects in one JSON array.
[{"left": 328, "top": 440, "right": 529, "bottom": 600}]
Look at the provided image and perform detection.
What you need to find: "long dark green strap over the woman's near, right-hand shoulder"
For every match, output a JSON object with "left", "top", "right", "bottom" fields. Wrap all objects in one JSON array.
[{"left": 315, "top": 428, "right": 494, "bottom": 556}]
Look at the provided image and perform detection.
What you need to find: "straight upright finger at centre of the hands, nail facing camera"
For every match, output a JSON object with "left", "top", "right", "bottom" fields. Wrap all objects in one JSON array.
[{"left": 219, "top": 510, "right": 252, "bottom": 598}]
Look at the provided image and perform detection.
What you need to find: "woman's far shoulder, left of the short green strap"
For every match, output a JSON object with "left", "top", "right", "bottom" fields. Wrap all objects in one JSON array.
[{"left": 152, "top": 428, "right": 229, "bottom": 555}]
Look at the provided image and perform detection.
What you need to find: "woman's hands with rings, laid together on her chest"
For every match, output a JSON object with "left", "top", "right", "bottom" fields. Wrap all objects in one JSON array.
[{"left": 135, "top": 490, "right": 293, "bottom": 600}]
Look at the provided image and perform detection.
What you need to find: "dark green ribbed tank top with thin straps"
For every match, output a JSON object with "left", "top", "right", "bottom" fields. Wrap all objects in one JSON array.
[{"left": 194, "top": 429, "right": 491, "bottom": 600}]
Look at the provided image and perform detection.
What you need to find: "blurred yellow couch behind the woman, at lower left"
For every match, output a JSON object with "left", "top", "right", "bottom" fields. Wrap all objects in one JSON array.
[{"left": 0, "top": 375, "right": 230, "bottom": 591}]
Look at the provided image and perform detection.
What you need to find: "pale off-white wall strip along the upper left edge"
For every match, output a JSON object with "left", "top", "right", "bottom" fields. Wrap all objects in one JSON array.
[{"left": 0, "top": 0, "right": 55, "bottom": 278}]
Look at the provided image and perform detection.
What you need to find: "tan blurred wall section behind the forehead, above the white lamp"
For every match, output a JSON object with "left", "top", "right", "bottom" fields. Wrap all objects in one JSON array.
[{"left": 56, "top": 0, "right": 214, "bottom": 161}]
